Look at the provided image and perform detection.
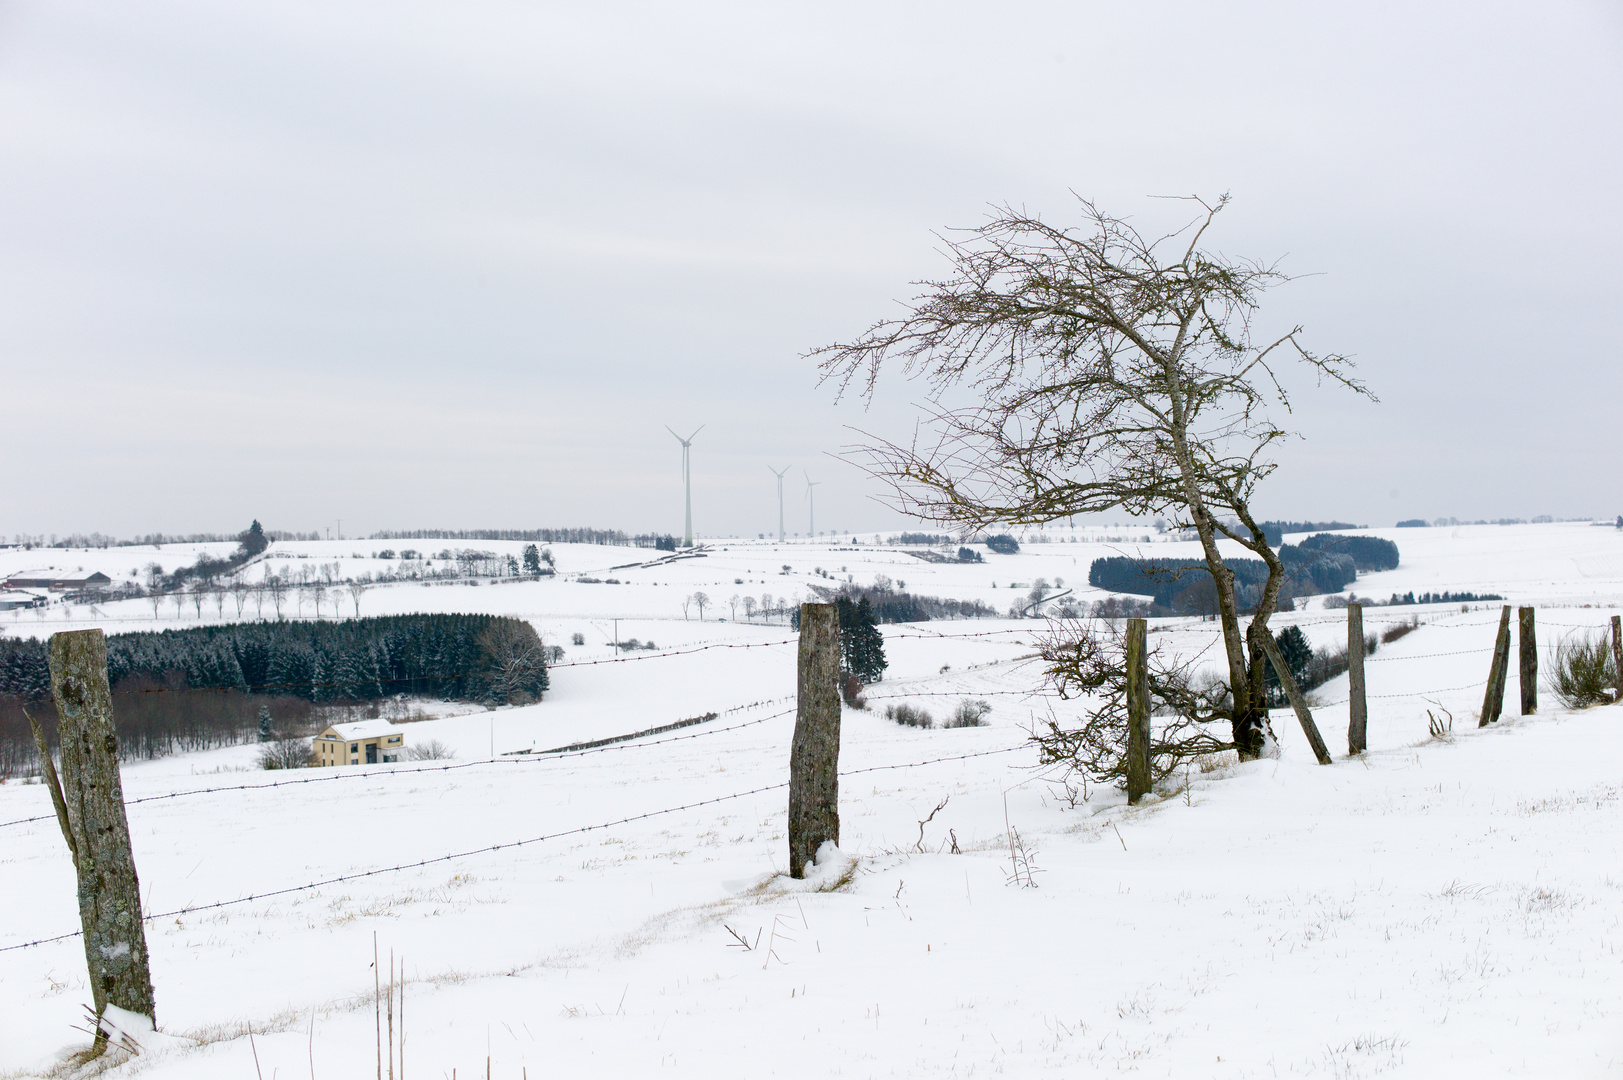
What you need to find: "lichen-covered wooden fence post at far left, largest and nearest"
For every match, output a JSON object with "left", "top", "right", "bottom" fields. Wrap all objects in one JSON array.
[{"left": 50, "top": 630, "right": 157, "bottom": 1051}]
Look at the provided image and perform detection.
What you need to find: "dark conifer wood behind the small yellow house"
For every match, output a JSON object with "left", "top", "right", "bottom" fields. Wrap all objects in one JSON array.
[{"left": 0, "top": 614, "right": 547, "bottom": 776}]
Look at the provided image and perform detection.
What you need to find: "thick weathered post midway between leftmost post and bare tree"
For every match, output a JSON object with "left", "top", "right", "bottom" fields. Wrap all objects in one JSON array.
[{"left": 789, "top": 604, "right": 839, "bottom": 877}]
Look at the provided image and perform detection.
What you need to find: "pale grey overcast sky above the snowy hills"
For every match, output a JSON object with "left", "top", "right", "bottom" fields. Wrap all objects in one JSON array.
[{"left": 0, "top": 0, "right": 1623, "bottom": 536}]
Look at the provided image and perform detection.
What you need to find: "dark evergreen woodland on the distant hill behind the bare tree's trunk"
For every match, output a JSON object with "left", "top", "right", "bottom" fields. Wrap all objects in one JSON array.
[{"left": 1087, "top": 533, "right": 1397, "bottom": 614}]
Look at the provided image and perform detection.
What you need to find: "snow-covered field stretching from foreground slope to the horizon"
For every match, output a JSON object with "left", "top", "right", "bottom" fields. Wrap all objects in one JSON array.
[{"left": 0, "top": 525, "right": 1623, "bottom": 1080}]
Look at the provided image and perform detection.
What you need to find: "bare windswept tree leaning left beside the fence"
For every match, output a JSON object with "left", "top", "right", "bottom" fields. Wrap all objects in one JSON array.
[{"left": 813, "top": 195, "right": 1373, "bottom": 757}]
